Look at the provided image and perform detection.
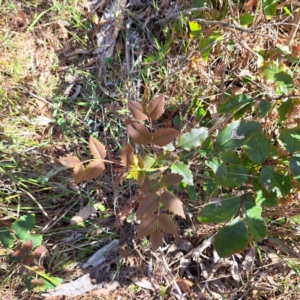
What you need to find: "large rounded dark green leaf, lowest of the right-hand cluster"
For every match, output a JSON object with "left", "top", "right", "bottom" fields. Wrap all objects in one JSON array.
[{"left": 214, "top": 217, "right": 248, "bottom": 257}]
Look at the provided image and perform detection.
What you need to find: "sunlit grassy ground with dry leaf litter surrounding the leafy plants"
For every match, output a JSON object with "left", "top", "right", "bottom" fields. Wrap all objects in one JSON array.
[{"left": 0, "top": 1, "right": 299, "bottom": 299}]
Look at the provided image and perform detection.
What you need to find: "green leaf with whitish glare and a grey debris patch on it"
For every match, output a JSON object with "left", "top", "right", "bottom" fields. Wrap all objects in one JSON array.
[{"left": 215, "top": 120, "right": 260, "bottom": 152}]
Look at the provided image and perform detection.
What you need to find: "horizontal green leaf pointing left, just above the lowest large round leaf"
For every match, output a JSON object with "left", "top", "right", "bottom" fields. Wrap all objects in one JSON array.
[{"left": 197, "top": 197, "right": 240, "bottom": 223}]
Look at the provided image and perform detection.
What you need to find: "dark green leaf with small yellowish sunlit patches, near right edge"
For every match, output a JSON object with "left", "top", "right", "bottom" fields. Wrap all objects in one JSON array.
[{"left": 261, "top": 166, "right": 292, "bottom": 197}]
